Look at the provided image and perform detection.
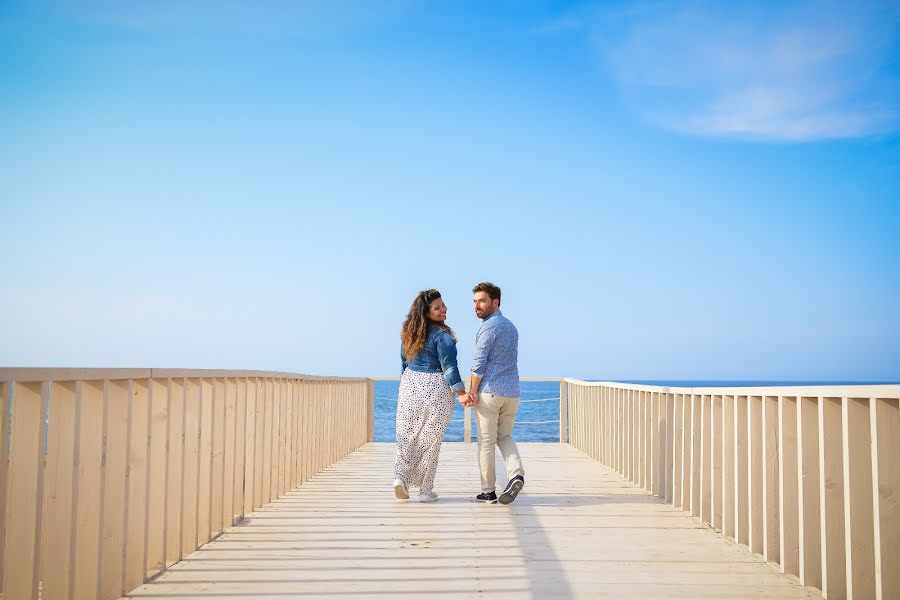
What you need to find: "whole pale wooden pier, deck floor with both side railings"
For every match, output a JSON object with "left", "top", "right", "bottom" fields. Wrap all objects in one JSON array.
[{"left": 0, "top": 369, "right": 900, "bottom": 600}]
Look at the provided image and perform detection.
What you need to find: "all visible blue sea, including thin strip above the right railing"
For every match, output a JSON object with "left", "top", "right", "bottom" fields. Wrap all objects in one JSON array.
[{"left": 375, "top": 379, "right": 881, "bottom": 442}]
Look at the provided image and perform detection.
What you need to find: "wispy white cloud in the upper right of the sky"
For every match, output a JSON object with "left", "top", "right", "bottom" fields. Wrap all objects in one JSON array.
[{"left": 591, "top": 1, "right": 900, "bottom": 141}]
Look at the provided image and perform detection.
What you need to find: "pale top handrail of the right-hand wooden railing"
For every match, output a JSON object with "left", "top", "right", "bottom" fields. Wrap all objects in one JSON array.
[{"left": 561, "top": 377, "right": 900, "bottom": 398}]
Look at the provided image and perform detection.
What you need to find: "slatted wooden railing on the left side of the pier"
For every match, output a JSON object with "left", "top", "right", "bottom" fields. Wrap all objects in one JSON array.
[{"left": 0, "top": 369, "right": 374, "bottom": 600}]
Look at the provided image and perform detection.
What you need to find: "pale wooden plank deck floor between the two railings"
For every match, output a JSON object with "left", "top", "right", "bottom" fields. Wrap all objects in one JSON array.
[{"left": 128, "top": 443, "right": 820, "bottom": 600}]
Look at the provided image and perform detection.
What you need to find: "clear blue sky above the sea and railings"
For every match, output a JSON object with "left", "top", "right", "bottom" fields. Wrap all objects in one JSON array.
[{"left": 0, "top": 0, "right": 900, "bottom": 381}]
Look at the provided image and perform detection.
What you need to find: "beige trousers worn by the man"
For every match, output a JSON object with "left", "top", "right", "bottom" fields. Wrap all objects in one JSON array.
[{"left": 475, "top": 394, "right": 525, "bottom": 492}]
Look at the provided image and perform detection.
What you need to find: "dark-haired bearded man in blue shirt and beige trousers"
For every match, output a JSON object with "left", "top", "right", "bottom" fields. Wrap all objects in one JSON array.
[{"left": 467, "top": 282, "right": 525, "bottom": 504}]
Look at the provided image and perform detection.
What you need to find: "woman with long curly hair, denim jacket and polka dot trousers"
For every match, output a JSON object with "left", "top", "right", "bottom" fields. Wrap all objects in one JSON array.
[{"left": 394, "top": 290, "right": 466, "bottom": 502}]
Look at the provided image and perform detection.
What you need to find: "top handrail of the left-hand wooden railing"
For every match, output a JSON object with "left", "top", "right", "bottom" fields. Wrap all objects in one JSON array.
[{"left": 0, "top": 367, "right": 367, "bottom": 383}]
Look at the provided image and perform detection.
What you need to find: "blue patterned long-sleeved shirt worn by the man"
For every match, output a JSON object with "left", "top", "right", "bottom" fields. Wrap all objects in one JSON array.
[{"left": 472, "top": 310, "right": 519, "bottom": 398}]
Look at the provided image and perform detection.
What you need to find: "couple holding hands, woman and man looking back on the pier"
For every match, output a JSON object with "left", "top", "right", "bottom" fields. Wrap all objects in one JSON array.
[{"left": 394, "top": 282, "right": 525, "bottom": 504}]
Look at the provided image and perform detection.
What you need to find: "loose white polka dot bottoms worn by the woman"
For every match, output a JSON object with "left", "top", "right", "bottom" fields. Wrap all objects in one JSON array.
[{"left": 394, "top": 369, "right": 454, "bottom": 492}]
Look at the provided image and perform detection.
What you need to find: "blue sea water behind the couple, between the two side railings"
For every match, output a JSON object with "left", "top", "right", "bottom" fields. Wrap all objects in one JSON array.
[{"left": 375, "top": 381, "right": 559, "bottom": 442}]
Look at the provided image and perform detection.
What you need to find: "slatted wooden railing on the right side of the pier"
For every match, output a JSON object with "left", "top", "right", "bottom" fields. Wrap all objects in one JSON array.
[{"left": 560, "top": 379, "right": 900, "bottom": 600}]
